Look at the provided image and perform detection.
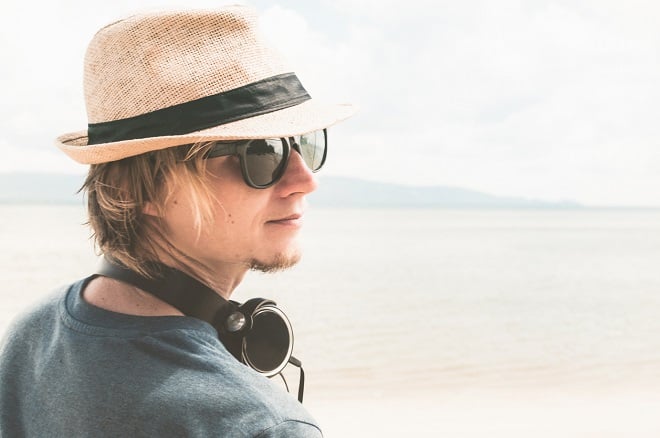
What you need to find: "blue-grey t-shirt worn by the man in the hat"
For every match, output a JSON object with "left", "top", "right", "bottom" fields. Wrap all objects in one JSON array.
[{"left": 0, "top": 278, "right": 321, "bottom": 438}]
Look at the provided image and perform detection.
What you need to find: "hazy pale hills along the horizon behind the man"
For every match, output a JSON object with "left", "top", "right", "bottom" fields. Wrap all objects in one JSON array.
[{"left": 0, "top": 173, "right": 581, "bottom": 208}]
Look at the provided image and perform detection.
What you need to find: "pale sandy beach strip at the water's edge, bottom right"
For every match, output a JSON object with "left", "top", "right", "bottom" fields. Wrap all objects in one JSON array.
[{"left": 306, "top": 389, "right": 660, "bottom": 438}]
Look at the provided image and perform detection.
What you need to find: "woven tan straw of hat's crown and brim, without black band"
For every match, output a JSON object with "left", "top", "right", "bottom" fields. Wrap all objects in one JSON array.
[{"left": 57, "top": 6, "right": 355, "bottom": 164}]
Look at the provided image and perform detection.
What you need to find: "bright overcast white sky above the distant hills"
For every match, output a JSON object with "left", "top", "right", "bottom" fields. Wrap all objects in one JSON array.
[{"left": 0, "top": 0, "right": 660, "bottom": 207}]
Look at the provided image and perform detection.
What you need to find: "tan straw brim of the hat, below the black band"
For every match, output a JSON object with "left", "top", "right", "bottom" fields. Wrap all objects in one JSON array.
[{"left": 56, "top": 100, "right": 357, "bottom": 164}]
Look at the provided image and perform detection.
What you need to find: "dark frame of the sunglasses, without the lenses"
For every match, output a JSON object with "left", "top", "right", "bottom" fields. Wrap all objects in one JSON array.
[{"left": 205, "top": 129, "right": 328, "bottom": 189}]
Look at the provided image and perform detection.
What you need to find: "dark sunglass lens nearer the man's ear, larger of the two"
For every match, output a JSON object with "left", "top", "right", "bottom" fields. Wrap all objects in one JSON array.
[{"left": 245, "top": 139, "right": 285, "bottom": 186}]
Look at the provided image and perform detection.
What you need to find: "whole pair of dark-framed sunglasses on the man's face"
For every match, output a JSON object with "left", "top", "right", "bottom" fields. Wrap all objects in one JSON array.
[{"left": 206, "top": 129, "right": 328, "bottom": 189}]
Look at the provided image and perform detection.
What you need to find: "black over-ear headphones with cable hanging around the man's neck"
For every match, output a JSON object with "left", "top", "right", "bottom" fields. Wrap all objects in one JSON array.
[{"left": 96, "top": 257, "right": 305, "bottom": 403}]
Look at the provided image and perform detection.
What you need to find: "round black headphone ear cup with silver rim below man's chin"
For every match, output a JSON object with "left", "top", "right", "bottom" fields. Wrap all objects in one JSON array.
[{"left": 239, "top": 298, "right": 293, "bottom": 377}]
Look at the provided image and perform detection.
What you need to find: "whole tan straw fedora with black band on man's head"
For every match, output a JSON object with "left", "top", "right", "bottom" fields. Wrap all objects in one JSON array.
[{"left": 57, "top": 6, "right": 355, "bottom": 164}]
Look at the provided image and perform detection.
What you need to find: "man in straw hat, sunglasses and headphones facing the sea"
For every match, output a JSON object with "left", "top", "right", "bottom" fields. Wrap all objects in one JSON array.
[{"left": 0, "top": 6, "right": 354, "bottom": 437}]
